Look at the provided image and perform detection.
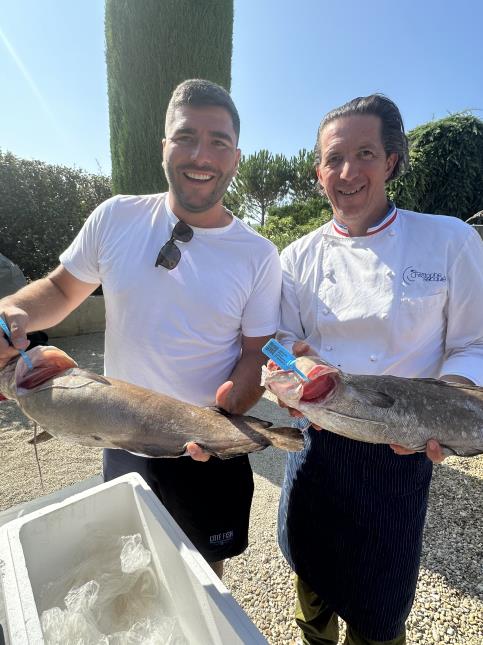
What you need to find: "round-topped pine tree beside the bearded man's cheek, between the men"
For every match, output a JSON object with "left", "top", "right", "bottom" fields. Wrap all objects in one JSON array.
[{"left": 233, "top": 150, "right": 290, "bottom": 226}]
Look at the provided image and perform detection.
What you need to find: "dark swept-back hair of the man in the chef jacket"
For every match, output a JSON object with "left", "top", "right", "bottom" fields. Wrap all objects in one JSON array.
[{"left": 315, "top": 94, "right": 409, "bottom": 181}]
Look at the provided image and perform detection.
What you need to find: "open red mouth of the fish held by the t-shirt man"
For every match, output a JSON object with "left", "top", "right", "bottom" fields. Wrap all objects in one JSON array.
[{"left": 15, "top": 345, "right": 77, "bottom": 394}]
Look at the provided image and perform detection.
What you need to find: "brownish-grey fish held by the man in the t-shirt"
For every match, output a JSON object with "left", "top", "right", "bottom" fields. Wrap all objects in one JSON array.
[{"left": 0, "top": 346, "right": 303, "bottom": 459}]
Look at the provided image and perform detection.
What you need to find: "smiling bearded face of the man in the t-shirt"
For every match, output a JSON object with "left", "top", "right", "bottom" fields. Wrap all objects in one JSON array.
[{"left": 163, "top": 106, "right": 240, "bottom": 216}]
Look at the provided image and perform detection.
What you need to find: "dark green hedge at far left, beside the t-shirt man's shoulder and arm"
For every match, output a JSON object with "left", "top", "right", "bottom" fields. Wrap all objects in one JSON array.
[{"left": 0, "top": 150, "right": 112, "bottom": 280}]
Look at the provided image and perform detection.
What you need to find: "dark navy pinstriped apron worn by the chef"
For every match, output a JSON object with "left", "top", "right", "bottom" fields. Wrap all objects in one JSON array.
[{"left": 278, "top": 428, "right": 432, "bottom": 641}]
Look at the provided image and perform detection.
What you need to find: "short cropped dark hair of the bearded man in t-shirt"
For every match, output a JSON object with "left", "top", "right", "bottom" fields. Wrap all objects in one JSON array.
[{"left": 164, "top": 78, "right": 240, "bottom": 143}]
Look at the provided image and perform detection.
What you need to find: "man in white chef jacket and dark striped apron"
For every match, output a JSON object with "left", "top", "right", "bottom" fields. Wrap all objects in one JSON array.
[{"left": 279, "top": 95, "right": 483, "bottom": 645}]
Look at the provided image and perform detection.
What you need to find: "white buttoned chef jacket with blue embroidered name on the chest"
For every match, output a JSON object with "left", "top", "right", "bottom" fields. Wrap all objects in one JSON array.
[{"left": 278, "top": 209, "right": 483, "bottom": 384}]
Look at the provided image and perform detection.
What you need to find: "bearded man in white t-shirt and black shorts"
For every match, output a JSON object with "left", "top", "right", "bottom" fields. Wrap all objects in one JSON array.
[{"left": 0, "top": 79, "right": 281, "bottom": 575}]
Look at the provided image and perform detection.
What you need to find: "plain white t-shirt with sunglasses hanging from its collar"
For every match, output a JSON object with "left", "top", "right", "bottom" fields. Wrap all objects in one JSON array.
[{"left": 60, "top": 193, "right": 281, "bottom": 406}]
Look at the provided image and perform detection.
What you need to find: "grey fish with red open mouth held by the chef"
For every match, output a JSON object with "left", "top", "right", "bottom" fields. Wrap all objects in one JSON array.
[{"left": 262, "top": 356, "right": 483, "bottom": 457}]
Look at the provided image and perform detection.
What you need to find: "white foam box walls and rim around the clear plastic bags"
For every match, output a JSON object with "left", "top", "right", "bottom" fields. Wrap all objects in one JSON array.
[{"left": 0, "top": 473, "right": 267, "bottom": 645}]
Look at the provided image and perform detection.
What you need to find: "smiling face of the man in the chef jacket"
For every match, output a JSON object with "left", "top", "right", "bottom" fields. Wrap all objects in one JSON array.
[{"left": 317, "top": 115, "right": 397, "bottom": 235}]
